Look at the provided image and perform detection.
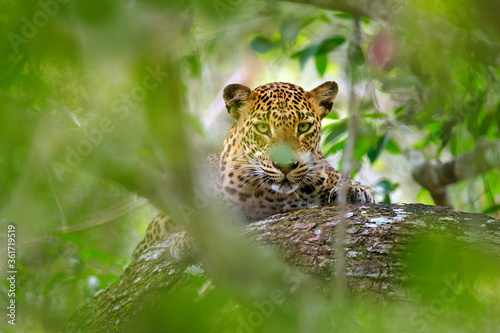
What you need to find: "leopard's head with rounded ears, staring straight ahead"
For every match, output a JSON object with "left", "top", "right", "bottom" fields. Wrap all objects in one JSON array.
[{"left": 222, "top": 81, "right": 338, "bottom": 193}]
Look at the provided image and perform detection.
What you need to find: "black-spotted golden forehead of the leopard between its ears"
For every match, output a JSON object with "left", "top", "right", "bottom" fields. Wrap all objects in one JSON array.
[{"left": 252, "top": 82, "right": 311, "bottom": 111}]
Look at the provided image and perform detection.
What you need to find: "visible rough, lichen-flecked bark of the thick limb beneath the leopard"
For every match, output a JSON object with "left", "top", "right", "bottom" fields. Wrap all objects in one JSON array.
[{"left": 63, "top": 204, "right": 500, "bottom": 333}]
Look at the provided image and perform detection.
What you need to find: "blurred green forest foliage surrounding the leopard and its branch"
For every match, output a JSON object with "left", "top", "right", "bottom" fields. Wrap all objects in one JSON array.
[{"left": 0, "top": 0, "right": 500, "bottom": 332}]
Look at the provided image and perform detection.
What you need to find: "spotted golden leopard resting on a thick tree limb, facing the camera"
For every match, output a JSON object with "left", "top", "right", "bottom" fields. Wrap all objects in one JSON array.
[{"left": 133, "top": 81, "right": 374, "bottom": 258}]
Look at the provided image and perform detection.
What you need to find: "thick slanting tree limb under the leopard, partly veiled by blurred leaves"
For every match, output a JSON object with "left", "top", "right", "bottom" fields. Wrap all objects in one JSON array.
[{"left": 63, "top": 204, "right": 500, "bottom": 333}]
